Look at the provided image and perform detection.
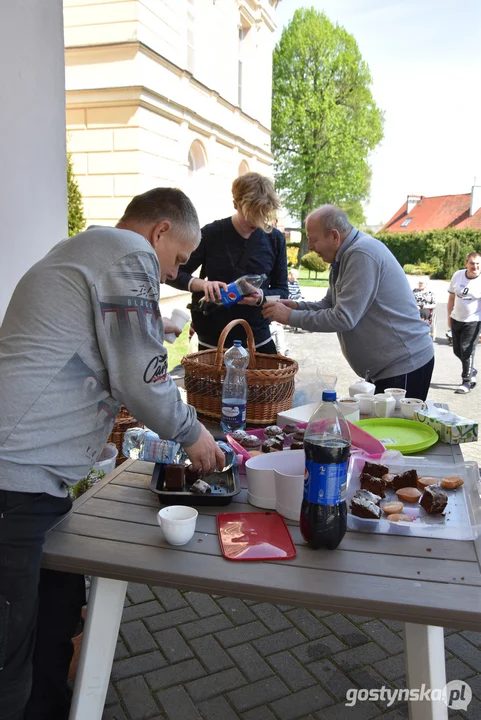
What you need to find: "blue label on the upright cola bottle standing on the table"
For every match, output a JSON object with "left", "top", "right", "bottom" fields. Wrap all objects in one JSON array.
[{"left": 304, "top": 458, "right": 348, "bottom": 505}]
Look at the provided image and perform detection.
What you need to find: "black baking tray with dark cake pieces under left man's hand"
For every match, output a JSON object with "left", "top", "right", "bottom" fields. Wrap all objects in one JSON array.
[{"left": 150, "top": 444, "right": 241, "bottom": 506}]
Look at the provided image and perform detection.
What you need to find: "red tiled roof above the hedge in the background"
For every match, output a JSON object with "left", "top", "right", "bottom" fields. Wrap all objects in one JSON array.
[{"left": 381, "top": 193, "right": 470, "bottom": 232}]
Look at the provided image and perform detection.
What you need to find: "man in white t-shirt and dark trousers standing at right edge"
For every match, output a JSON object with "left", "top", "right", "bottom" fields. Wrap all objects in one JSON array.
[{"left": 448, "top": 252, "right": 481, "bottom": 393}]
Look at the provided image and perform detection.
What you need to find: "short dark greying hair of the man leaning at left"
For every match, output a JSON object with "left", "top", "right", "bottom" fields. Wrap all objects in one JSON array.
[{"left": 120, "top": 188, "right": 200, "bottom": 243}]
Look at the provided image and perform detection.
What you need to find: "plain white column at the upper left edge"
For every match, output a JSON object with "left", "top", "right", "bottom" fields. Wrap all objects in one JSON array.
[{"left": 0, "top": 0, "right": 67, "bottom": 323}]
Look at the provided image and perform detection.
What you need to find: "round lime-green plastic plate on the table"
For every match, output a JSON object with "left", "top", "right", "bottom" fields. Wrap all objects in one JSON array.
[{"left": 354, "top": 418, "right": 439, "bottom": 455}]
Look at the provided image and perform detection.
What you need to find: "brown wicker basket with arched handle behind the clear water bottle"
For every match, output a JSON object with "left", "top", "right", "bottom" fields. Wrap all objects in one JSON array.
[{"left": 182, "top": 320, "right": 298, "bottom": 427}]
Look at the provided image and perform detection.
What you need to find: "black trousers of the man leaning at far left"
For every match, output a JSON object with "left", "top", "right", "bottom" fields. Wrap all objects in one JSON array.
[{"left": 0, "top": 490, "right": 85, "bottom": 720}]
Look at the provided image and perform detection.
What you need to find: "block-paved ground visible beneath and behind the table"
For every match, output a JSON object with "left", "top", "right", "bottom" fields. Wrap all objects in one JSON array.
[{"left": 103, "top": 285, "right": 481, "bottom": 720}]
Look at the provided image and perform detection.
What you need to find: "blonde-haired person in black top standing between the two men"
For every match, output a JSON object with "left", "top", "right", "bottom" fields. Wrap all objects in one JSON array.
[{"left": 168, "top": 172, "right": 288, "bottom": 353}]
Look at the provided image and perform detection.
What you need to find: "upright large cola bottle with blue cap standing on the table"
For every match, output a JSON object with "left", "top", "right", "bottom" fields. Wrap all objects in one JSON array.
[{"left": 300, "top": 390, "right": 351, "bottom": 550}]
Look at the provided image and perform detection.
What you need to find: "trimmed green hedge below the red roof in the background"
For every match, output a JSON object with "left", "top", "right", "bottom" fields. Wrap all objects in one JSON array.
[{"left": 376, "top": 228, "right": 481, "bottom": 279}]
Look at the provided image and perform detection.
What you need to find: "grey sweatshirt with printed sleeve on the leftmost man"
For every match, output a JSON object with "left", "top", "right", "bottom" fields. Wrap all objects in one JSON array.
[{"left": 0, "top": 227, "right": 200, "bottom": 496}]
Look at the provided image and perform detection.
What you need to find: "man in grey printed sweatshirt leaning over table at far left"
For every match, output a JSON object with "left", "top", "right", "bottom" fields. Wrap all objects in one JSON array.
[{"left": 0, "top": 188, "right": 224, "bottom": 720}]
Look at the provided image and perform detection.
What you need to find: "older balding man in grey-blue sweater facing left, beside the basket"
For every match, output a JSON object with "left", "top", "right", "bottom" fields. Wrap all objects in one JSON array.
[{"left": 263, "top": 205, "right": 434, "bottom": 400}]
